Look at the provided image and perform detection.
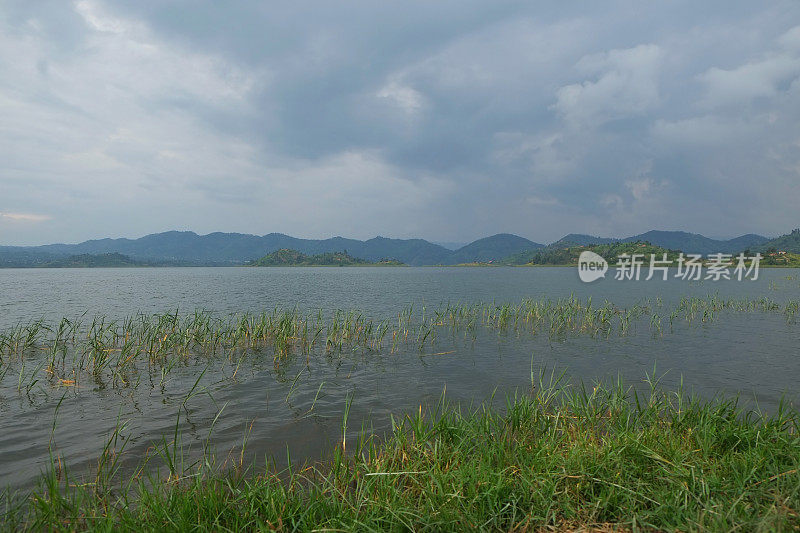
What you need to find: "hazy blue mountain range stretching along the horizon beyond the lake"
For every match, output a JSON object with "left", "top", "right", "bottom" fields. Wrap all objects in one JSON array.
[{"left": 0, "top": 230, "right": 800, "bottom": 267}]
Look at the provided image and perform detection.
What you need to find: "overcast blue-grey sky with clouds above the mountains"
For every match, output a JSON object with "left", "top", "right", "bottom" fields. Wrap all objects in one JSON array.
[{"left": 0, "top": 0, "right": 800, "bottom": 244}]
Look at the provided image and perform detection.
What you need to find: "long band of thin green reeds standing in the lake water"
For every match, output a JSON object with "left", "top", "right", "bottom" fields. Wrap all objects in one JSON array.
[{"left": 0, "top": 295, "right": 800, "bottom": 391}]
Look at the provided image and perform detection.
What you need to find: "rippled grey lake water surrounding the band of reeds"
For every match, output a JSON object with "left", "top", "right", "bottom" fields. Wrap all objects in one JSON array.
[{"left": 0, "top": 267, "right": 800, "bottom": 488}]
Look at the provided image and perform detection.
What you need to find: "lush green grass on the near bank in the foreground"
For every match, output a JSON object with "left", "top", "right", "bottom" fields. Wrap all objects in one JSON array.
[{"left": 4, "top": 372, "right": 800, "bottom": 531}]
